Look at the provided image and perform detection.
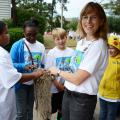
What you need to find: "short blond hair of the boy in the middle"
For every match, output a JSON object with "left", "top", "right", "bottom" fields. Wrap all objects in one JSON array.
[{"left": 52, "top": 28, "right": 67, "bottom": 39}]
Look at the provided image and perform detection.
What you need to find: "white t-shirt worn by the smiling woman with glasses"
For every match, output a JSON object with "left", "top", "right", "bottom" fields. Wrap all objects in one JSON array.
[{"left": 65, "top": 39, "right": 108, "bottom": 95}]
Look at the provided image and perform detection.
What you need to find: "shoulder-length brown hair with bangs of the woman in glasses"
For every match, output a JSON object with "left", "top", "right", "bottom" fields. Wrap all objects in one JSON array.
[{"left": 77, "top": 2, "right": 108, "bottom": 40}]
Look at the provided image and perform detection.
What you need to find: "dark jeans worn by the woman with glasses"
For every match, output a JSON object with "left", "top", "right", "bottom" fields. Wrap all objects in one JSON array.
[{"left": 62, "top": 90, "right": 97, "bottom": 120}]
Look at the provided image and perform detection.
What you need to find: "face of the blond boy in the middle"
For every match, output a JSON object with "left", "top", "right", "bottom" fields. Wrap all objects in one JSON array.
[{"left": 54, "top": 36, "right": 67, "bottom": 50}]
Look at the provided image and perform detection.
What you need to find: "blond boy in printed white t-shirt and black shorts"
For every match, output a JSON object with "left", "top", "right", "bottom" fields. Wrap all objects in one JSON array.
[{"left": 46, "top": 28, "right": 74, "bottom": 120}]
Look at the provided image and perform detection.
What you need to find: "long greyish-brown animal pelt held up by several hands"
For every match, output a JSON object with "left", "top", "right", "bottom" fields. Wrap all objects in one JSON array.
[{"left": 34, "top": 71, "right": 55, "bottom": 120}]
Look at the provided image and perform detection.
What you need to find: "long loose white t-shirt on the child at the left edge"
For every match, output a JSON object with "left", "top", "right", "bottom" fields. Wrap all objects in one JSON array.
[{"left": 0, "top": 47, "right": 22, "bottom": 120}]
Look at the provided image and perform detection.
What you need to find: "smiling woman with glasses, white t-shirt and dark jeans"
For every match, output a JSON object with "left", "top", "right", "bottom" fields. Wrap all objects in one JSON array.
[{"left": 50, "top": 2, "right": 108, "bottom": 120}]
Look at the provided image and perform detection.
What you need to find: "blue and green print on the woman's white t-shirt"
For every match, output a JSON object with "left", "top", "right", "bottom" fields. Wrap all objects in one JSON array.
[{"left": 70, "top": 50, "right": 84, "bottom": 72}]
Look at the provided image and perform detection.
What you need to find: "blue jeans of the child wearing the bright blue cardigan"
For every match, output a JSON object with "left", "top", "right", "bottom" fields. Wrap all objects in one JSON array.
[{"left": 15, "top": 84, "right": 34, "bottom": 120}]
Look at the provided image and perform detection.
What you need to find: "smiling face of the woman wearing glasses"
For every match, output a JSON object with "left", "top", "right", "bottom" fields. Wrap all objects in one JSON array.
[{"left": 81, "top": 11, "right": 101, "bottom": 37}]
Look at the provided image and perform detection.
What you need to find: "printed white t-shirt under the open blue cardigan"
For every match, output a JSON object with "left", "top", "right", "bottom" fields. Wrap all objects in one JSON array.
[{"left": 24, "top": 38, "right": 45, "bottom": 85}]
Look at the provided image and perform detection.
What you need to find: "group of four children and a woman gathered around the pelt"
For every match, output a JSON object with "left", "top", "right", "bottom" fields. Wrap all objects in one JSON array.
[{"left": 0, "top": 2, "right": 120, "bottom": 120}]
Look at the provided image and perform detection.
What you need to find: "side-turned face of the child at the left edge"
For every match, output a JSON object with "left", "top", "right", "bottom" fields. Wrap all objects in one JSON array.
[{"left": 0, "top": 26, "right": 10, "bottom": 47}]
